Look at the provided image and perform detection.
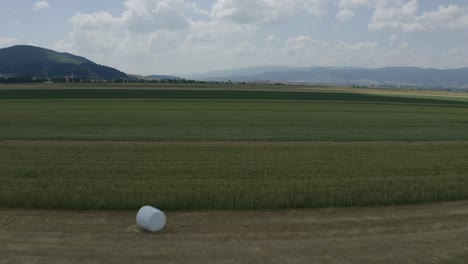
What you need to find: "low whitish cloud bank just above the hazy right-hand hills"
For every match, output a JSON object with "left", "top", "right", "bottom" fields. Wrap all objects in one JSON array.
[{"left": 270, "top": 32, "right": 468, "bottom": 68}]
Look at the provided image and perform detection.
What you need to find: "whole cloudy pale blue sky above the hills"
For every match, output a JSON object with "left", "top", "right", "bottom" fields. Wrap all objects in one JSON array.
[{"left": 0, "top": 0, "right": 468, "bottom": 75}]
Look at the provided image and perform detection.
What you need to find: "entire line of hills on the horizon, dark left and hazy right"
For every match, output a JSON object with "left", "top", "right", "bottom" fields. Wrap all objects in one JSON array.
[{"left": 0, "top": 45, "right": 468, "bottom": 89}]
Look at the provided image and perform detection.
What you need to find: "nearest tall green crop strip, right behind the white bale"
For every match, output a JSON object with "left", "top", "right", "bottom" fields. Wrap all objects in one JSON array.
[{"left": 0, "top": 141, "right": 468, "bottom": 209}]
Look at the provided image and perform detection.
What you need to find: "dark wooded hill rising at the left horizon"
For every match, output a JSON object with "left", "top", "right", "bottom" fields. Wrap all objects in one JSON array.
[{"left": 0, "top": 45, "right": 129, "bottom": 80}]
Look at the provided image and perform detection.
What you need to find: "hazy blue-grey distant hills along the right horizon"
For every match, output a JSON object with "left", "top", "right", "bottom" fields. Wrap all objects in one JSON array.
[{"left": 188, "top": 66, "right": 468, "bottom": 89}]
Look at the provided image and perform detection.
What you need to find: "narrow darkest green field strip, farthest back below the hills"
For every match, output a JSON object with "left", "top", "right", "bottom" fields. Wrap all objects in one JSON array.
[{"left": 0, "top": 89, "right": 468, "bottom": 107}]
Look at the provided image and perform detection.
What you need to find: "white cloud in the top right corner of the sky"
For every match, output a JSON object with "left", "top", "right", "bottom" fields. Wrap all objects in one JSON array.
[{"left": 368, "top": 0, "right": 468, "bottom": 32}]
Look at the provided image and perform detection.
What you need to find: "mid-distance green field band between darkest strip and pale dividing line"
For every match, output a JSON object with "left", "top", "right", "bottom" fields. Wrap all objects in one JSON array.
[{"left": 0, "top": 99, "right": 468, "bottom": 141}]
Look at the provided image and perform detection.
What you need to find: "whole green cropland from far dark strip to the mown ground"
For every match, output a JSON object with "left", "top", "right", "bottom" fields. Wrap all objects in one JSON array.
[{"left": 0, "top": 85, "right": 468, "bottom": 209}]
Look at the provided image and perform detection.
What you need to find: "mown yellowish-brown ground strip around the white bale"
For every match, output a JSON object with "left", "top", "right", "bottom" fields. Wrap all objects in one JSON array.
[{"left": 0, "top": 201, "right": 468, "bottom": 263}]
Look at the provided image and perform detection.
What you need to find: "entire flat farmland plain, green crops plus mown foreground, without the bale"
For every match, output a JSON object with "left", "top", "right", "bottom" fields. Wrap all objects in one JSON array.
[{"left": 0, "top": 84, "right": 468, "bottom": 263}]
